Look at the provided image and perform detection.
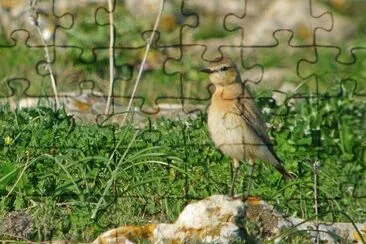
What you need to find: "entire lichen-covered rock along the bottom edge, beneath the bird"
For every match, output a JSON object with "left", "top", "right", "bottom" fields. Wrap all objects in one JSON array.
[{"left": 92, "top": 195, "right": 366, "bottom": 244}]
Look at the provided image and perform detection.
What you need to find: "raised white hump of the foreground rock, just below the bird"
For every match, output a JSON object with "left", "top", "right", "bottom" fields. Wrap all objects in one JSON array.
[{"left": 159, "top": 195, "right": 244, "bottom": 243}]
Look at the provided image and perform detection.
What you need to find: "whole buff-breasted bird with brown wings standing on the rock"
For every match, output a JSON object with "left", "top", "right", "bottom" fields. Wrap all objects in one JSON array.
[{"left": 201, "top": 57, "right": 293, "bottom": 197}]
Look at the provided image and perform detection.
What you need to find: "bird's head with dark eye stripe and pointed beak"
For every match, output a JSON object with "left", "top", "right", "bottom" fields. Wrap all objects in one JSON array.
[{"left": 201, "top": 58, "right": 240, "bottom": 86}]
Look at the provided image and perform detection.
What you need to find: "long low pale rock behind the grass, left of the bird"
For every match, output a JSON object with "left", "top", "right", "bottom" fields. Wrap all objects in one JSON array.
[{"left": 10, "top": 89, "right": 206, "bottom": 124}]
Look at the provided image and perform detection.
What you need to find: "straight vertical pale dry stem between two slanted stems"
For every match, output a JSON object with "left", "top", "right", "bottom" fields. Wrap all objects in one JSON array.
[{"left": 104, "top": 0, "right": 114, "bottom": 114}]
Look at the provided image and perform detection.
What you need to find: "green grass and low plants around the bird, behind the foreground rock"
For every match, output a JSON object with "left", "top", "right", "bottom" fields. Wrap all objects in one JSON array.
[{"left": 0, "top": 82, "right": 366, "bottom": 241}]
